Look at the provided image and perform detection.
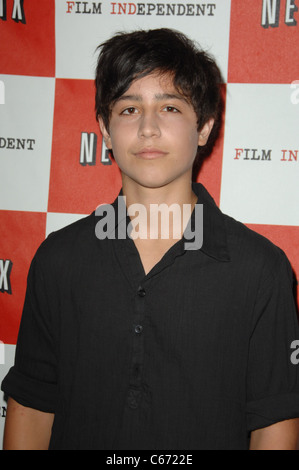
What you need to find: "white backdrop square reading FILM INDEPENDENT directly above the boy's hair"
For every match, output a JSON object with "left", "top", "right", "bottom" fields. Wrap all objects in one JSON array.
[{"left": 55, "top": 0, "right": 231, "bottom": 82}]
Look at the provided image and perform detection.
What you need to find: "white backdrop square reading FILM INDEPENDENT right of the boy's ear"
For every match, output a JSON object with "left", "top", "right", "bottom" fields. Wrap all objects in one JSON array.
[{"left": 220, "top": 84, "right": 299, "bottom": 225}]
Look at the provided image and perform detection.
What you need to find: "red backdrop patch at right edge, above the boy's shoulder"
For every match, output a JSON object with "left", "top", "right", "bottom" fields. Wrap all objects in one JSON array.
[{"left": 246, "top": 224, "right": 299, "bottom": 306}]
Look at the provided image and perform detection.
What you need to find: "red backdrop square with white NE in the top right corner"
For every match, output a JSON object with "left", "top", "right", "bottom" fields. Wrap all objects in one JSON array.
[{"left": 228, "top": 0, "right": 299, "bottom": 84}]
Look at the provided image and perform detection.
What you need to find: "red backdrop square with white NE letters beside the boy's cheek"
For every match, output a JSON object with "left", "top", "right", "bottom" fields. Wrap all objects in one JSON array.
[{"left": 48, "top": 79, "right": 121, "bottom": 214}]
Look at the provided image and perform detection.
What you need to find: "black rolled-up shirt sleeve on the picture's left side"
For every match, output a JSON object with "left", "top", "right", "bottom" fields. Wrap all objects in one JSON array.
[{"left": 1, "top": 244, "right": 57, "bottom": 413}]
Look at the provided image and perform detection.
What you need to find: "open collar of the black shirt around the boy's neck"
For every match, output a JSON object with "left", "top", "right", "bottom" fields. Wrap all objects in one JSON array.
[{"left": 98, "top": 183, "right": 230, "bottom": 261}]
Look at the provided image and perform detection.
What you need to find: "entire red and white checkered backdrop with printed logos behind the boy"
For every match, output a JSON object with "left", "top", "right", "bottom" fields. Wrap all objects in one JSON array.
[{"left": 0, "top": 0, "right": 299, "bottom": 446}]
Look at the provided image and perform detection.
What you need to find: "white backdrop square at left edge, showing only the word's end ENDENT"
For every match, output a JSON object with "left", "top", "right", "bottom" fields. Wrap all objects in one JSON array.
[{"left": 0, "top": 75, "right": 55, "bottom": 212}]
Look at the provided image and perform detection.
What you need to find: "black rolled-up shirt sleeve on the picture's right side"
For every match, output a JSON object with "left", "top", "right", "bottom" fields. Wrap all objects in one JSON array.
[{"left": 246, "top": 250, "right": 299, "bottom": 432}]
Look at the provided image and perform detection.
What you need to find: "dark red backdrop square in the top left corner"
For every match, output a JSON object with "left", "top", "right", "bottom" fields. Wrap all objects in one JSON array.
[{"left": 0, "top": 0, "right": 55, "bottom": 77}]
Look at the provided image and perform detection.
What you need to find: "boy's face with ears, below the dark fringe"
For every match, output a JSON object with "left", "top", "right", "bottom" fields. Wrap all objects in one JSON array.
[{"left": 100, "top": 73, "right": 213, "bottom": 188}]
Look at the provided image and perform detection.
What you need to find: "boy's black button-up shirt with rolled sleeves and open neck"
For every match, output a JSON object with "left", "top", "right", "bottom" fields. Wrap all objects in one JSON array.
[{"left": 2, "top": 184, "right": 299, "bottom": 450}]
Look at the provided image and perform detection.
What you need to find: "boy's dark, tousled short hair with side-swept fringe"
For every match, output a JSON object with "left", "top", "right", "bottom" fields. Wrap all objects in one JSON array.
[{"left": 95, "top": 28, "right": 222, "bottom": 167}]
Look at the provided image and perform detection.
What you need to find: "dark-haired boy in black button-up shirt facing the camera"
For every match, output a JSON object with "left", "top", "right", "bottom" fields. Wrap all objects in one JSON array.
[{"left": 2, "top": 29, "right": 299, "bottom": 451}]
